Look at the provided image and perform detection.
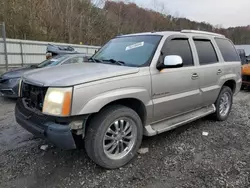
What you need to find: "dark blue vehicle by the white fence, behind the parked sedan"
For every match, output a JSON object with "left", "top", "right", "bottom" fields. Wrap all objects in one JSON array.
[{"left": 46, "top": 44, "right": 79, "bottom": 59}]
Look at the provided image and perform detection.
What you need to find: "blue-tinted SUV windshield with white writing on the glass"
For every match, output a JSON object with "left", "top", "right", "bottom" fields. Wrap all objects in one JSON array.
[{"left": 92, "top": 35, "right": 161, "bottom": 67}]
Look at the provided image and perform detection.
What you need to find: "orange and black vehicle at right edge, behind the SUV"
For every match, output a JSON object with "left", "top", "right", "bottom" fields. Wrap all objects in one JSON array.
[{"left": 238, "top": 49, "right": 250, "bottom": 89}]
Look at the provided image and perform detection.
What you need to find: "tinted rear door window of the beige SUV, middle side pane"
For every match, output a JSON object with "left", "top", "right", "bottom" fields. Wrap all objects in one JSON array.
[{"left": 194, "top": 39, "right": 218, "bottom": 65}]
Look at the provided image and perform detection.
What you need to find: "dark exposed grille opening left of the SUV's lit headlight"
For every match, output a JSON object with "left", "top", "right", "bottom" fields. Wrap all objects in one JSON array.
[{"left": 21, "top": 83, "right": 48, "bottom": 111}]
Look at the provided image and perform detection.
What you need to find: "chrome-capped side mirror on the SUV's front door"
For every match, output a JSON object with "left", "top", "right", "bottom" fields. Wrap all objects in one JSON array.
[{"left": 157, "top": 55, "right": 183, "bottom": 69}]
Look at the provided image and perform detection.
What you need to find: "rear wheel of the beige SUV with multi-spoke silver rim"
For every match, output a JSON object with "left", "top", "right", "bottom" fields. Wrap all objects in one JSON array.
[{"left": 214, "top": 86, "right": 233, "bottom": 121}]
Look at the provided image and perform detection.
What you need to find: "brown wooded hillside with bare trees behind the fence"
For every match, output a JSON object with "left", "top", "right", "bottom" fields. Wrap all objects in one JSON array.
[{"left": 0, "top": 0, "right": 250, "bottom": 45}]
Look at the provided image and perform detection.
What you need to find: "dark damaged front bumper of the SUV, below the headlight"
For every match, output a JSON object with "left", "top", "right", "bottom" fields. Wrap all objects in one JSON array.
[{"left": 15, "top": 99, "right": 76, "bottom": 150}]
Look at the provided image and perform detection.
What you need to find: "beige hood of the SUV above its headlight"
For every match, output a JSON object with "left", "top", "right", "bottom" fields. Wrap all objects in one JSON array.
[{"left": 23, "top": 63, "right": 139, "bottom": 87}]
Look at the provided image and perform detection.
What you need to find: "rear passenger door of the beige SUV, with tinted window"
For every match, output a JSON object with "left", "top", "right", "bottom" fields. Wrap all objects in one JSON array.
[{"left": 193, "top": 37, "right": 224, "bottom": 106}]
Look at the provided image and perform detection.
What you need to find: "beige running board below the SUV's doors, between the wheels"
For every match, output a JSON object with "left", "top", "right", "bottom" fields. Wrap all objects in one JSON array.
[{"left": 144, "top": 104, "right": 216, "bottom": 136}]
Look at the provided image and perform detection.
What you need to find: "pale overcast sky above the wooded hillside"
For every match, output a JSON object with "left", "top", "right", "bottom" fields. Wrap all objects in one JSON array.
[{"left": 130, "top": 0, "right": 250, "bottom": 27}]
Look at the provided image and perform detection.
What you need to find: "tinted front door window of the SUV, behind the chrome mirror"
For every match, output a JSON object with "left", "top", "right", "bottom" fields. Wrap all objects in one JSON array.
[{"left": 162, "top": 38, "right": 194, "bottom": 67}]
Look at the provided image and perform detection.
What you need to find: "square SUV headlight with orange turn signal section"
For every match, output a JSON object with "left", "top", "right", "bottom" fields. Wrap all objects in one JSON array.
[{"left": 43, "top": 87, "right": 72, "bottom": 116}]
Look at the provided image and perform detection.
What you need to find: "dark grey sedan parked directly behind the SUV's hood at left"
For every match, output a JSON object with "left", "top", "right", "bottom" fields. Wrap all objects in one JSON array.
[{"left": 0, "top": 53, "right": 88, "bottom": 98}]
